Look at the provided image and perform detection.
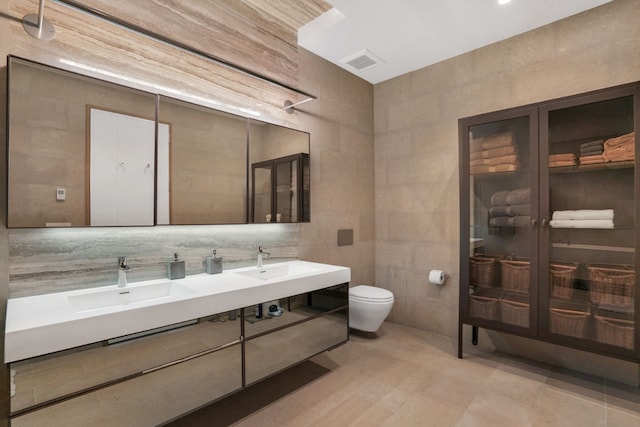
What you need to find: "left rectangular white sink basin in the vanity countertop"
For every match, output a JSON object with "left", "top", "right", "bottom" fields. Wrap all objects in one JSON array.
[{"left": 67, "top": 281, "right": 195, "bottom": 312}]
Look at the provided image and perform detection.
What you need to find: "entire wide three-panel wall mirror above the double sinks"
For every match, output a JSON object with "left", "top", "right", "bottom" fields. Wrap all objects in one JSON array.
[{"left": 7, "top": 57, "right": 310, "bottom": 228}]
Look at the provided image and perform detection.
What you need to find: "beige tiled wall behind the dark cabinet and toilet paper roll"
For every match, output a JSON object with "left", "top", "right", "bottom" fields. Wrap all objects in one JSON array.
[{"left": 374, "top": 0, "right": 640, "bottom": 382}]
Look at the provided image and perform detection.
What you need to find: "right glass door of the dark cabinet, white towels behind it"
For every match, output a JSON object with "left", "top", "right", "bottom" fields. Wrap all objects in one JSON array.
[{"left": 540, "top": 89, "right": 637, "bottom": 354}]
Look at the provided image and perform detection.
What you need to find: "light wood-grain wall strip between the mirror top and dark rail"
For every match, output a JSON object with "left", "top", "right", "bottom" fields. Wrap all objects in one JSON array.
[{"left": 8, "top": 0, "right": 312, "bottom": 127}]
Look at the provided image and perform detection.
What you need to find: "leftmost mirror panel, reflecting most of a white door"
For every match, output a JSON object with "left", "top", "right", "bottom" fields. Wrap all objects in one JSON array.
[{"left": 7, "top": 57, "right": 156, "bottom": 231}]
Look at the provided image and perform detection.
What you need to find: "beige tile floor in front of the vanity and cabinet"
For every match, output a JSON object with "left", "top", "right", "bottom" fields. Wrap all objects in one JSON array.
[{"left": 168, "top": 322, "right": 640, "bottom": 427}]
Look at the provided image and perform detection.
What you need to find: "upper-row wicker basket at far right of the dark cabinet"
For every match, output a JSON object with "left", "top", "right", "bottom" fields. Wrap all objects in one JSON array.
[{"left": 589, "top": 267, "right": 635, "bottom": 306}]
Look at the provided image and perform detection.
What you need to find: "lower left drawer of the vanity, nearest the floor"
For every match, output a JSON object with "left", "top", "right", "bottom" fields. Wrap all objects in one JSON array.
[{"left": 11, "top": 344, "right": 242, "bottom": 427}]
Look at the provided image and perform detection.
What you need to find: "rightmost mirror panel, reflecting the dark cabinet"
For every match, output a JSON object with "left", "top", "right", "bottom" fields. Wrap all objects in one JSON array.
[{"left": 249, "top": 120, "right": 310, "bottom": 223}]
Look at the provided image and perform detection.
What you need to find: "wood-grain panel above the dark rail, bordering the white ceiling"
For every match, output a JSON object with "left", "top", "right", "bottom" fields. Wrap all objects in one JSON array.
[{"left": 63, "top": 0, "right": 331, "bottom": 86}]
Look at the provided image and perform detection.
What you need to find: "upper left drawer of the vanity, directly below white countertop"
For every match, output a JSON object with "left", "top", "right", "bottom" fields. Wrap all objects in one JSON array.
[{"left": 10, "top": 313, "right": 241, "bottom": 413}]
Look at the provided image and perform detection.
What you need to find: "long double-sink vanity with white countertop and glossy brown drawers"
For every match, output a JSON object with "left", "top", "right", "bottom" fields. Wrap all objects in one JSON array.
[{"left": 5, "top": 261, "right": 350, "bottom": 426}]
